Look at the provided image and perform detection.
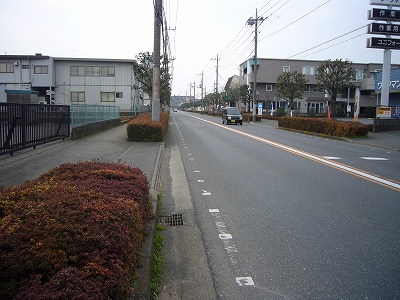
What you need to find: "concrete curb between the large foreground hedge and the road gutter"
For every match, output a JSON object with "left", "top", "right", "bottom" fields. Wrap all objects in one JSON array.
[{"left": 131, "top": 142, "right": 165, "bottom": 300}]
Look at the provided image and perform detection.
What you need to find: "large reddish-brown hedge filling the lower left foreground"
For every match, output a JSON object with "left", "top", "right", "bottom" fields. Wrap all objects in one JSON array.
[{"left": 0, "top": 161, "right": 152, "bottom": 299}]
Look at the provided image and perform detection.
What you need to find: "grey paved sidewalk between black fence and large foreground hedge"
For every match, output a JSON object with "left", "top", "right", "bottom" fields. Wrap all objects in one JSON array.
[{"left": 0, "top": 124, "right": 161, "bottom": 186}]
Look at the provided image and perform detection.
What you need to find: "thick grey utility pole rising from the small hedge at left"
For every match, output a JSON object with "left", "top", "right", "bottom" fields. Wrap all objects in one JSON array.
[{"left": 151, "top": 0, "right": 163, "bottom": 122}]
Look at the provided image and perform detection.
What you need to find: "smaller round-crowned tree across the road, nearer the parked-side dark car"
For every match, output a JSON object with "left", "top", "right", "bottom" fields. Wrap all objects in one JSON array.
[{"left": 276, "top": 71, "right": 308, "bottom": 115}]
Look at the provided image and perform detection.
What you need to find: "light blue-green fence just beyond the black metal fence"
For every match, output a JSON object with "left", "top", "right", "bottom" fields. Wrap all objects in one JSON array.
[{"left": 71, "top": 104, "right": 120, "bottom": 127}]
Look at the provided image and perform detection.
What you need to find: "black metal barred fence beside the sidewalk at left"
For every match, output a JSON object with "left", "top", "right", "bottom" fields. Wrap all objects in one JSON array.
[{"left": 0, "top": 103, "right": 71, "bottom": 155}]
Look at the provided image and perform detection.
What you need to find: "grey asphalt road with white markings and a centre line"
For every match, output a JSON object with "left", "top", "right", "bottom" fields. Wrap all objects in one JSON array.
[{"left": 168, "top": 112, "right": 400, "bottom": 299}]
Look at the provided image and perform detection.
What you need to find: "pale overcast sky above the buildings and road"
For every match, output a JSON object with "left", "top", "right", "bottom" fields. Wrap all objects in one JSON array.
[{"left": 0, "top": 0, "right": 400, "bottom": 97}]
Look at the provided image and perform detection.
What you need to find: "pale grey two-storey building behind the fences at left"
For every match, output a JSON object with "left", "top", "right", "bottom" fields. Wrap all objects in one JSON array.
[{"left": 0, "top": 53, "right": 144, "bottom": 111}]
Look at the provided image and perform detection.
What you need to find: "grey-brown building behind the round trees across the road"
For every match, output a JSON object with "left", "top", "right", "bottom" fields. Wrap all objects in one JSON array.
[{"left": 240, "top": 58, "right": 400, "bottom": 113}]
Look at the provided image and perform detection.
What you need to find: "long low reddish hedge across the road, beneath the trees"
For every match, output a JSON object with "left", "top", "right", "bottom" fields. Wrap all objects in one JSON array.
[{"left": 278, "top": 117, "right": 368, "bottom": 137}]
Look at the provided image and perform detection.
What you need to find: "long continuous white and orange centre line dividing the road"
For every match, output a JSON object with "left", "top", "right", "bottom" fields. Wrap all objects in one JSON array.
[{"left": 185, "top": 114, "right": 400, "bottom": 191}]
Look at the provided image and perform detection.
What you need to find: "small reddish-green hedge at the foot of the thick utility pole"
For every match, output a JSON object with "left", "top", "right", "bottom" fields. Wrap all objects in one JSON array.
[{"left": 127, "top": 112, "right": 168, "bottom": 142}]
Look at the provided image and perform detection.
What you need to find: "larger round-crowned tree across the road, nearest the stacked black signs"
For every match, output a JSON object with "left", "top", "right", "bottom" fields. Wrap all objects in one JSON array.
[{"left": 316, "top": 59, "right": 355, "bottom": 118}]
